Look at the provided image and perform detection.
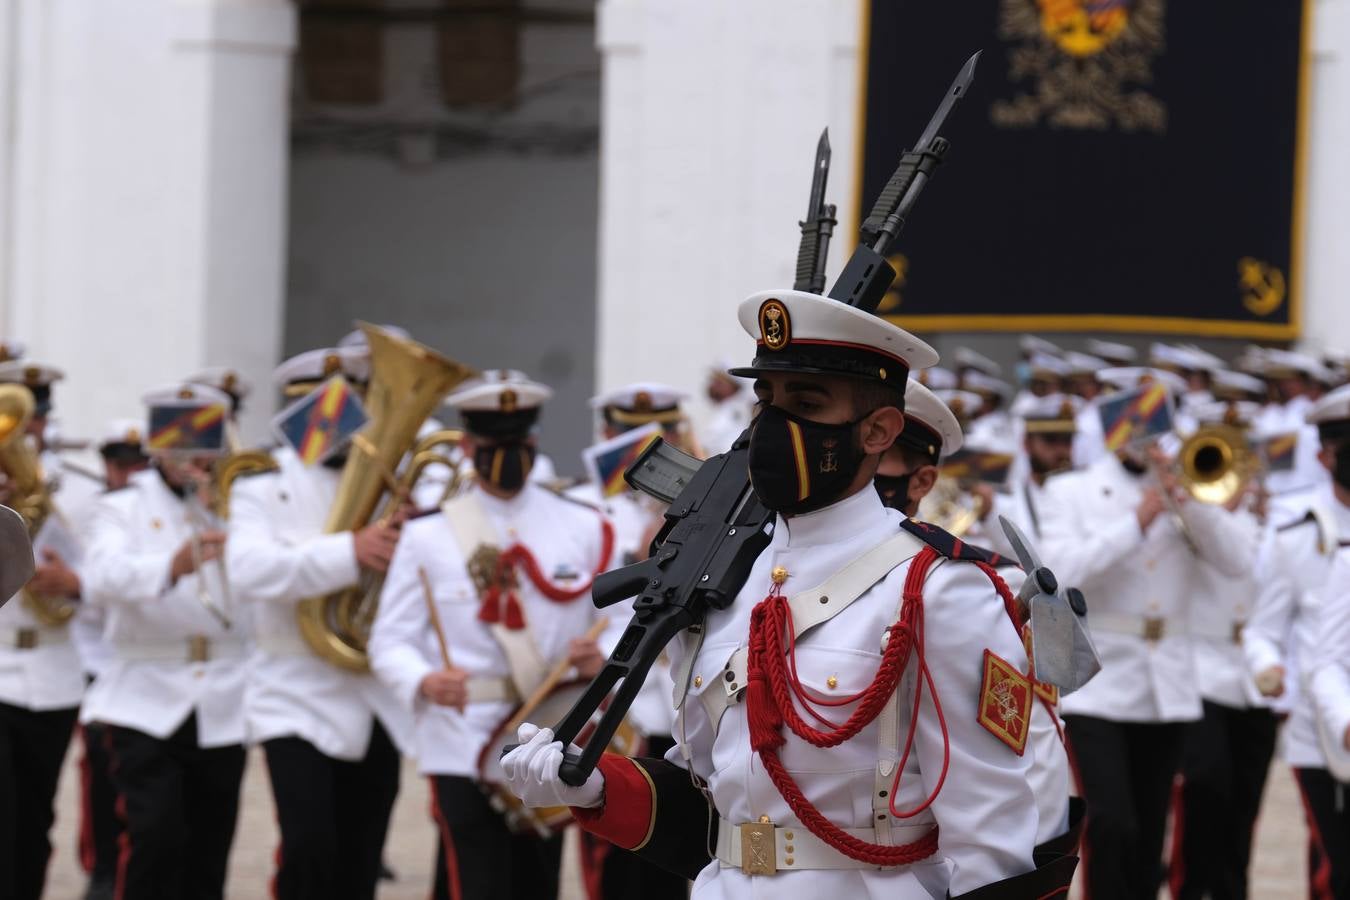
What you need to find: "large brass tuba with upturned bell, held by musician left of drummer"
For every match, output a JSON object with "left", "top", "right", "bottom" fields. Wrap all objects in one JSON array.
[{"left": 296, "top": 322, "right": 474, "bottom": 672}]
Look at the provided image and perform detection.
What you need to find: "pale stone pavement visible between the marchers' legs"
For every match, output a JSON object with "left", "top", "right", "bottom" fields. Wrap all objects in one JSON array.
[{"left": 46, "top": 745, "right": 1307, "bottom": 900}]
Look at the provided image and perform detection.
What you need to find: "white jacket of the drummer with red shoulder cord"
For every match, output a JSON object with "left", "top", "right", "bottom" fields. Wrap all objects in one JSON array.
[{"left": 370, "top": 483, "right": 626, "bottom": 777}]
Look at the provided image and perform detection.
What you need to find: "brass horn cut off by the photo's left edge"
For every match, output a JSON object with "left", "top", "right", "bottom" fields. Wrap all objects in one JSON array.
[{"left": 0, "top": 385, "right": 76, "bottom": 627}]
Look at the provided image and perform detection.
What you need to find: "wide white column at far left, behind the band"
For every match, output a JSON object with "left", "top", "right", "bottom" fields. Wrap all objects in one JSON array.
[{"left": 0, "top": 0, "right": 294, "bottom": 447}]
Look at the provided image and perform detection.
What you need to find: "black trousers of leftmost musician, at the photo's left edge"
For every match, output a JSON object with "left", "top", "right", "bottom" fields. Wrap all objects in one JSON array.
[{"left": 0, "top": 703, "right": 78, "bottom": 900}]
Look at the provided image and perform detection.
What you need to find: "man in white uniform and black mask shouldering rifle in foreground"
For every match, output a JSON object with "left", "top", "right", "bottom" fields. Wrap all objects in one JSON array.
[{"left": 504, "top": 290, "right": 1072, "bottom": 900}]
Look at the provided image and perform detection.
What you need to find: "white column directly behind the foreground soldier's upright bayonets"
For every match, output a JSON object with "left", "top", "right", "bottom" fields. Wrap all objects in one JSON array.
[{"left": 598, "top": 0, "right": 860, "bottom": 423}]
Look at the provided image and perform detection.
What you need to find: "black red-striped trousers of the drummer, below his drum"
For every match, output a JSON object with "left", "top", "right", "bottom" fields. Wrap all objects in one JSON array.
[{"left": 431, "top": 775, "right": 563, "bottom": 900}]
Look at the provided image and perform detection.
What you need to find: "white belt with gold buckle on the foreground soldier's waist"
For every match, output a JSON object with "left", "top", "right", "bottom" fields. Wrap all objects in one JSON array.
[{"left": 717, "top": 819, "right": 933, "bottom": 874}]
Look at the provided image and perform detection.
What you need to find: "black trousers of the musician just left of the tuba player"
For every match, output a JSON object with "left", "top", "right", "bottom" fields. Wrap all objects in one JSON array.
[{"left": 108, "top": 712, "right": 244, "bottom": 900}]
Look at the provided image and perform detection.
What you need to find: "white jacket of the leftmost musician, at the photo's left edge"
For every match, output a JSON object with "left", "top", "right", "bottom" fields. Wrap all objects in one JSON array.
[{"left": 0, "top": 472, "right": 85, "bottom": 711}]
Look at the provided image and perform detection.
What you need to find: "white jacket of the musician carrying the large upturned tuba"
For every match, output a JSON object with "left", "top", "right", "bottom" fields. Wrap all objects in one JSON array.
[{"left": 225, "top": 448, "right": 412, "bottom": 760}]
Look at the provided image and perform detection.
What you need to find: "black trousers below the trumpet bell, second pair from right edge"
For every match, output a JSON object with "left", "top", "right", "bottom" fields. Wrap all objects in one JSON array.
[{"left": 1170, "top": 700, "right": 1278, "bottom": 900}]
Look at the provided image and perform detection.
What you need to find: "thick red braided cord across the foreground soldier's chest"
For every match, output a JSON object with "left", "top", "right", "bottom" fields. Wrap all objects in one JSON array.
[{"left": 745, "top": 548, "right": 938, "bottom": 866}]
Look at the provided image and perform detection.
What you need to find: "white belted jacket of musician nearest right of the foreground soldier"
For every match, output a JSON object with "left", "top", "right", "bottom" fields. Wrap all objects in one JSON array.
[{"left": 1040, "top": 455, "right": 1256, "bottom": 722}]
